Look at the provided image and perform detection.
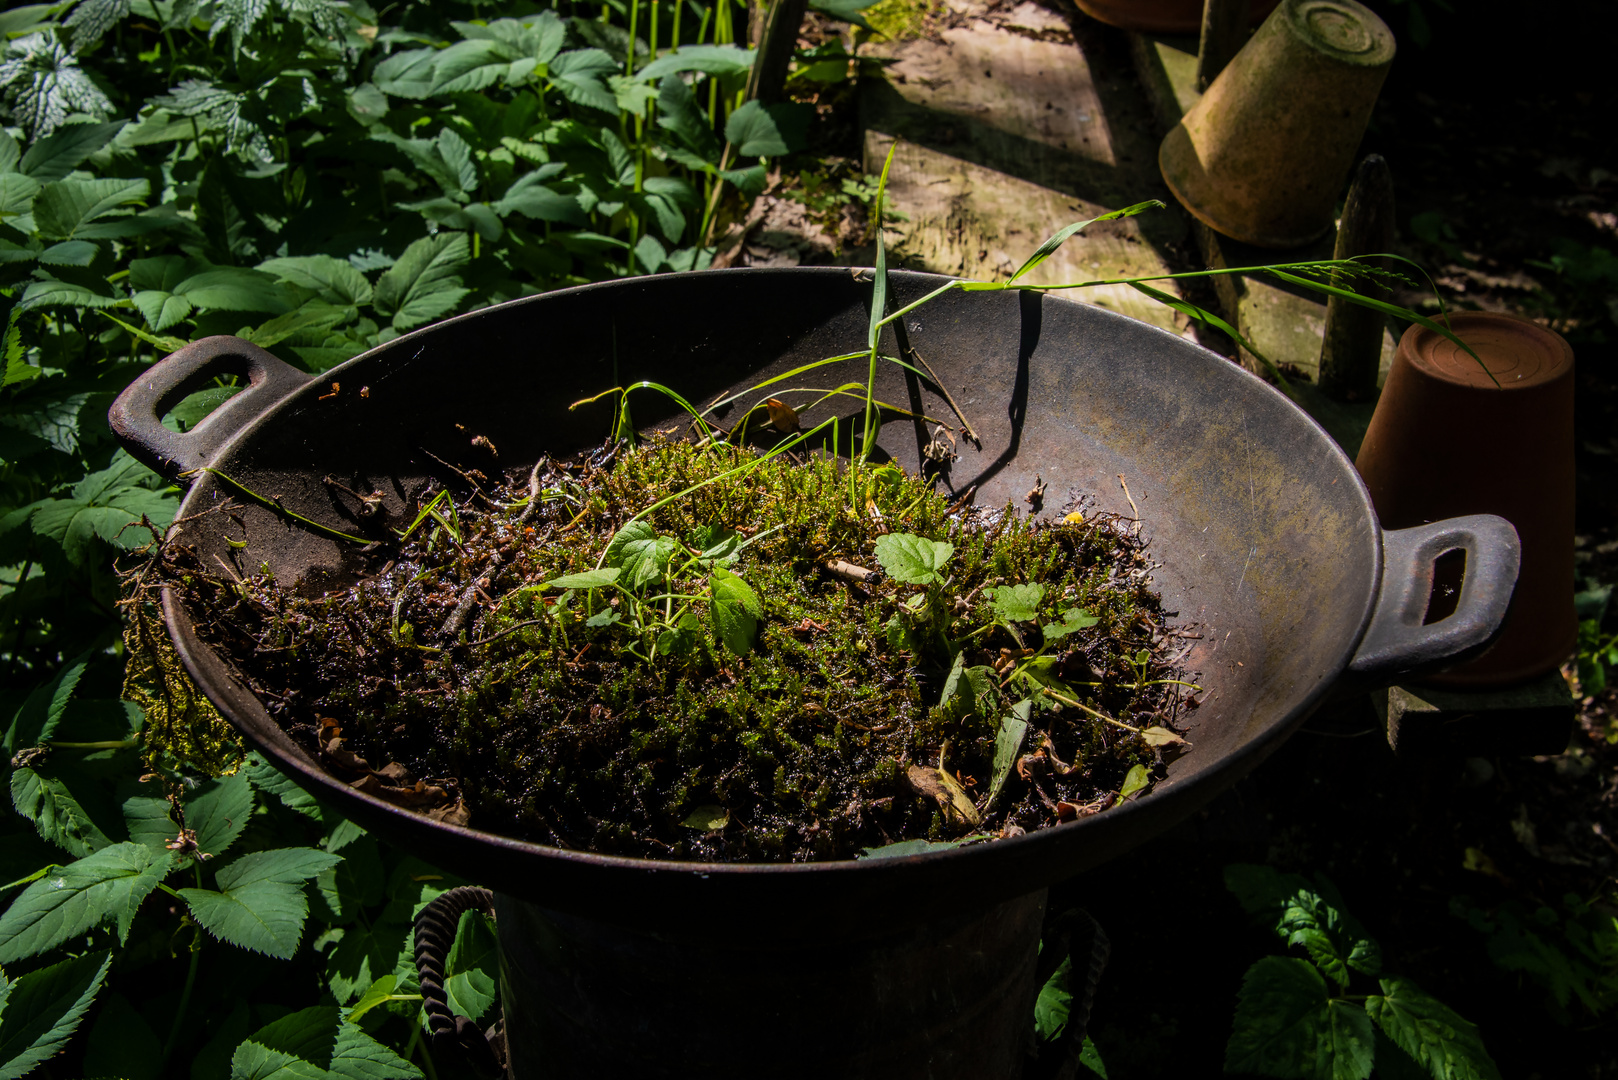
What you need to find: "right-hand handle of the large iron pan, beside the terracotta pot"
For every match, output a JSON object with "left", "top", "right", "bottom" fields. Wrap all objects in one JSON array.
[{"left": 1348, "top": 513, "right": 1523, "bottom": 685}]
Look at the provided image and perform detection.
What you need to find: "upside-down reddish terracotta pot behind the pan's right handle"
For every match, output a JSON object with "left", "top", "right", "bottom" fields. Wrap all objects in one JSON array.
[{"left": 1354, "top": 311, "right": 1578, "bottom": 688}]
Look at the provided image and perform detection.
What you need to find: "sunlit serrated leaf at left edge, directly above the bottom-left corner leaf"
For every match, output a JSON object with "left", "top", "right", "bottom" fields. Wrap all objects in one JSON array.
[{"left": 0, "top": 842, "right": 170, "bottom": 963}]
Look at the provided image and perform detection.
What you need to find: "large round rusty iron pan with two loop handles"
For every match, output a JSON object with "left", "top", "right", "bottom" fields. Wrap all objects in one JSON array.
[{"left": 110, "top": 269, "right": 1518, "bottom": 934}]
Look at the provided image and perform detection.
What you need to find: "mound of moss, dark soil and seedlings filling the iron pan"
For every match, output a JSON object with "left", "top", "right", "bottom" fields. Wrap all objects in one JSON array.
[{"left": 167, "top": 440, "right": 1189, "bottom": 861}]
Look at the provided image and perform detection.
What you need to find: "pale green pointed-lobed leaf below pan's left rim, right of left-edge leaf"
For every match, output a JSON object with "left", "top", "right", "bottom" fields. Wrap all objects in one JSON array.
[{"left": 180, "top": 847, "right": 341, "bottom": 960}]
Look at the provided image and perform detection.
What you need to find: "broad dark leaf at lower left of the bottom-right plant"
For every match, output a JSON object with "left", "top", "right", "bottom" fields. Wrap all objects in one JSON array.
[{"left": 1225, "top": 957, "right": 1375, "bottom": 1080}]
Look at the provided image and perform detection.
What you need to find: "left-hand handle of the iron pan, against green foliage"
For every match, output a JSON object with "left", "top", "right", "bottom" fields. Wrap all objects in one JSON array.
[{"left": 107, "top": 335, "right": 314, "bottom": 479}]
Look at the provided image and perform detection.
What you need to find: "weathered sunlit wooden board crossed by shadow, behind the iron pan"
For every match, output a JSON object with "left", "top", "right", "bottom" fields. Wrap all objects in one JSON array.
[{"left": 861, "top": 0, "right": 1189, "bottom": 335}]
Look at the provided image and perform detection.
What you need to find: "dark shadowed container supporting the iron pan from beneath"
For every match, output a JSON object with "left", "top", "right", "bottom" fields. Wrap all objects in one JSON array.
[{"left": 495, "top": 889, "right": 1045, "bottom": 1080}]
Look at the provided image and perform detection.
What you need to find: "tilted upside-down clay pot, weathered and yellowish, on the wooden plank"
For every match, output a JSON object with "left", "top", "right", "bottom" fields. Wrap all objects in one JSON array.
[{"left": 1157, "top": 0, "right": 1395, "bottom": 248}]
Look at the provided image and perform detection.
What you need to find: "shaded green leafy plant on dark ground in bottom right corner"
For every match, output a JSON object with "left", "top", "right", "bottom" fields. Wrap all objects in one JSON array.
[{"left": 1225, "top": 863, "right": 1500, "bottom": 1080}]
